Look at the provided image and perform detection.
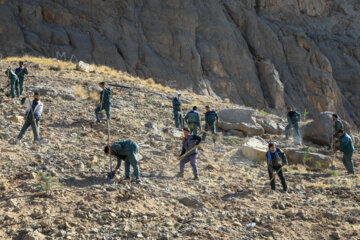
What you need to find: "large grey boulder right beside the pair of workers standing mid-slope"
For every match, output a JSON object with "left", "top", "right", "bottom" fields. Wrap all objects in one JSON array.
[{"left": 218, "top": 108, "right": 265, "bottom": 137}]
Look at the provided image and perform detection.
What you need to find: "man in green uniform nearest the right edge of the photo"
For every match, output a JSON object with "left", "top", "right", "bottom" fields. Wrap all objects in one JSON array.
[{"left": 334, "top": 129, "right": 355, "bottom": 174}]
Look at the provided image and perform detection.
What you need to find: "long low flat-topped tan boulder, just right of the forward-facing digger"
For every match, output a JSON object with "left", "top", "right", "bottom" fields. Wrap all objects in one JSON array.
[{"left": 283, "top": 148, "right": 331, "bottom": 168}]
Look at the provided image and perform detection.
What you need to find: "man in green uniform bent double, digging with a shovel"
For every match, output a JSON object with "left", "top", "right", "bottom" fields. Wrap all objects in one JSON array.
[{"left": 104, "top": 140, "right": 141, "bottom": 183}]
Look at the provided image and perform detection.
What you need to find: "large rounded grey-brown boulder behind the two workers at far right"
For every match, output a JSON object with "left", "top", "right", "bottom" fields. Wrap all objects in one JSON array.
[{"left": 301, "top": 112, "right": 351, "bottom": 145}]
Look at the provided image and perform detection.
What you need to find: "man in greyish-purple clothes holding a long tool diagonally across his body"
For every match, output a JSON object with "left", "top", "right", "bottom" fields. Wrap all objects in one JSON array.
[{"left": 176, "top": 128, "right": 201, "bottom": 180}]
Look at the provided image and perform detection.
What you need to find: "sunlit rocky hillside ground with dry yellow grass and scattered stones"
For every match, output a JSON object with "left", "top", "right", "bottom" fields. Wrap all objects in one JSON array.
[{"left": 0, "top": 58, "right": 360, "bottom": 240}]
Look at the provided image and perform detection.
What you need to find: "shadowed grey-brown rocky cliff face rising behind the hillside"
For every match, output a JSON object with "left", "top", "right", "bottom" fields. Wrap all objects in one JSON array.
[{"left": 0, "top": 0, "right": 360, "bottom": 125}]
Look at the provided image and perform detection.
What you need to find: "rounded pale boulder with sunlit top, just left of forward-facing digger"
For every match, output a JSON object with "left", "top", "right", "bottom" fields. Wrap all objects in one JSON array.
[{"left": 241, "top": 136, "right": 268, "bottom": 162}]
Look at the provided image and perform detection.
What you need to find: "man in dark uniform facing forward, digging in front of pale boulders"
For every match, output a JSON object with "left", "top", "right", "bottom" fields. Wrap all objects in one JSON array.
[{"left": 266, "top": 143, "right": 288, "bottom": 192}]
